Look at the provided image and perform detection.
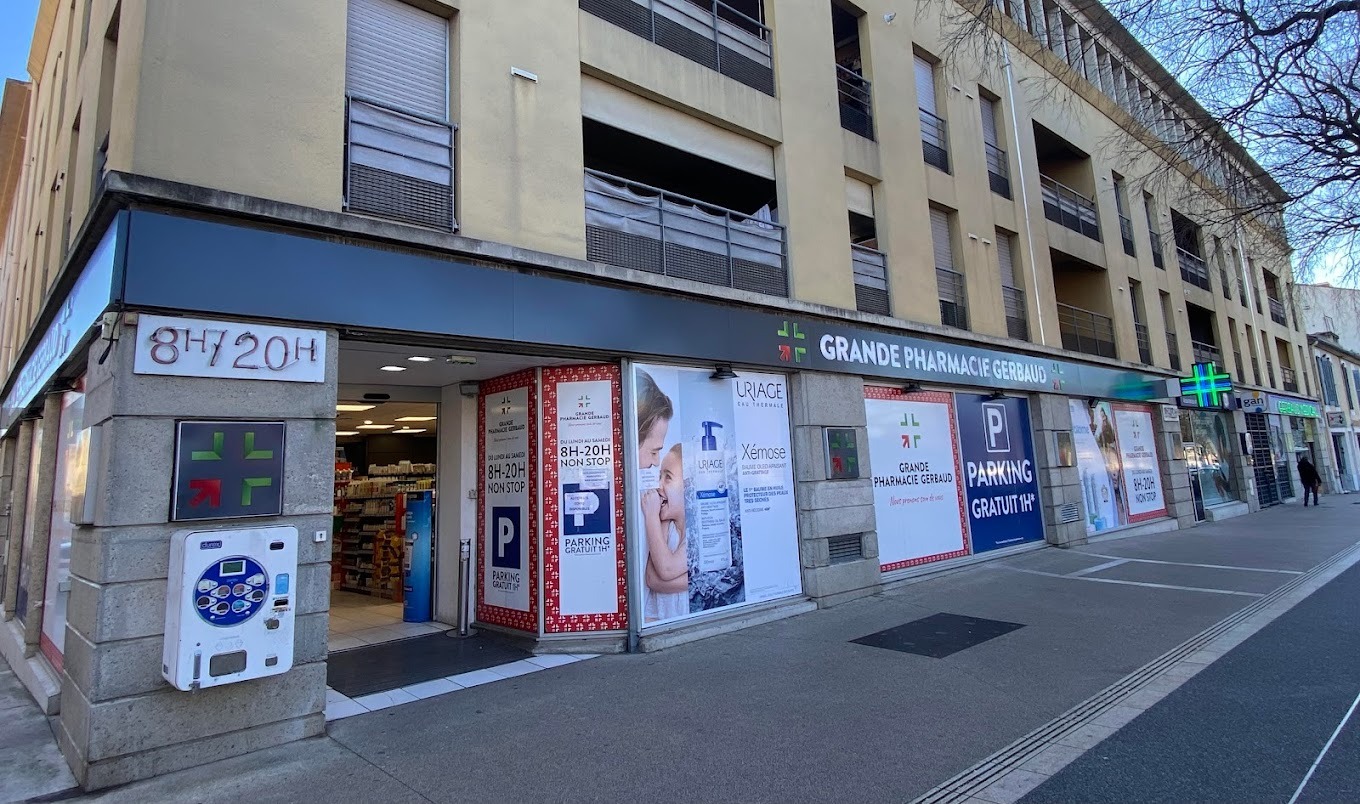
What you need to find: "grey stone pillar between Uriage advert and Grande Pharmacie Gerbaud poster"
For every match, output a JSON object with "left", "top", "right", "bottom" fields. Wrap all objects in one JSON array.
[{"left": 790, "top": 371, "right": 880, "bottom": 605}]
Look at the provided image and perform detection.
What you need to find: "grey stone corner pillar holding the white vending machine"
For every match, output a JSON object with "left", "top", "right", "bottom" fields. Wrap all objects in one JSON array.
[{"left": 57, "top": 325, "right": 339, "bottom": 789}]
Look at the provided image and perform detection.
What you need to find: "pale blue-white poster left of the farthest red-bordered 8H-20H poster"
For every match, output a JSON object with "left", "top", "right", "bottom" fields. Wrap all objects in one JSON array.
[{"left": 1068, "top": 399, "right": 1129, "bottom": 533}]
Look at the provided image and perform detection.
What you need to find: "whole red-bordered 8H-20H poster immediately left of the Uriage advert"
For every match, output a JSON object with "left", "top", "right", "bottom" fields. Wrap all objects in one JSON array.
[{"left": 543, "top": 366, "right": 628, "bottom": 633}]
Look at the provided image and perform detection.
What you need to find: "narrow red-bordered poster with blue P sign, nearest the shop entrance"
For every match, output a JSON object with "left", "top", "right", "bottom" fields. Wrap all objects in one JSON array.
[{"left": 477, "top": 371, "right": 539, "bottom": 631}]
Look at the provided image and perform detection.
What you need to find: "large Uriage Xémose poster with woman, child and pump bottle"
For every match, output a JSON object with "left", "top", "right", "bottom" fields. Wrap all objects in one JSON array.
[{"left": 632, "top": 365, "right": 802, "bottom": 626}]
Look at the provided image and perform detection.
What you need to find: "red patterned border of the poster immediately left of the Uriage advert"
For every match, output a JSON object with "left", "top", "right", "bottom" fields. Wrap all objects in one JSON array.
[{"left": 543, "top": 365, "right": 628, "bottom": 634}]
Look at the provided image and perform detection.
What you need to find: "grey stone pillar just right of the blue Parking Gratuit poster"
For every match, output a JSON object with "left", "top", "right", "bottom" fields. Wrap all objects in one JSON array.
[{"left": 1030, "top": 393, "right": 1087, "bottom": 547}]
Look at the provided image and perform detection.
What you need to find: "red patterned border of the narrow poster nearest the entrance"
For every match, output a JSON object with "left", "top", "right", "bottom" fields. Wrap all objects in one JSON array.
[{"left": 476, "top": 369, "right": 539, "bottom": 634}]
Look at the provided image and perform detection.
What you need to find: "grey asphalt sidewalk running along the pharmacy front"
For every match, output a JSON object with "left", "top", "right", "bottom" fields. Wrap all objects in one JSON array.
[{"left": 0, "top": 497, "right": 1360, "bottom": 803}]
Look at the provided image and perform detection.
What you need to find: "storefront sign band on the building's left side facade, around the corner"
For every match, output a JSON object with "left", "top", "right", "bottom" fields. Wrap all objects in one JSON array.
[{"left": 0, "top": 224, "right": 118, "bottom": 435}]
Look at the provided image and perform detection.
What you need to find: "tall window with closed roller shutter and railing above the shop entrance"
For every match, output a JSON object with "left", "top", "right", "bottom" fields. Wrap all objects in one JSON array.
[{"left": 344, "top": 0, "right": 457, "bottom": 230}]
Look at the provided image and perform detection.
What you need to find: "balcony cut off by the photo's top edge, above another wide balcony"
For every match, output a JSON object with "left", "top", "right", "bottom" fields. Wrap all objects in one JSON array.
[{"left": 579, "top": 0, "right": 774, "bottom": 95}]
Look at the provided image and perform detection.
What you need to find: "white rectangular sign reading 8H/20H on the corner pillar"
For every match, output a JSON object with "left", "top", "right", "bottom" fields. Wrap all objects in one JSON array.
[{"left": 132, "top": 314, "right": 326, "bottom": 382}]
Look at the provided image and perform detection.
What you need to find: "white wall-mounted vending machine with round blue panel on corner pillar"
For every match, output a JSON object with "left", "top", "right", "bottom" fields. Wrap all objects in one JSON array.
[{"left": 160, "top": 526, "right": 298, "bottom": 690}]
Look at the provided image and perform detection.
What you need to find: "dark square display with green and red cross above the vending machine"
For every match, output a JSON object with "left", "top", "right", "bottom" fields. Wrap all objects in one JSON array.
[{"left": 171, "top": 422, "right": 284, "bottom": 521}]
